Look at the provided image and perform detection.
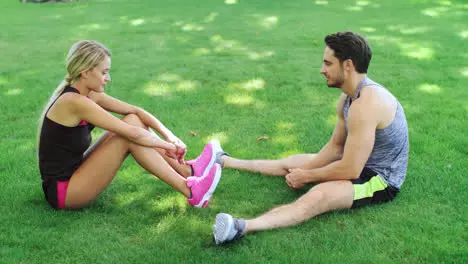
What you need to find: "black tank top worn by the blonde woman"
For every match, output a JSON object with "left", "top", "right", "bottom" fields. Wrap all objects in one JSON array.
[{"left": 39, "top": 86, "right": 94, "bottom": 181}]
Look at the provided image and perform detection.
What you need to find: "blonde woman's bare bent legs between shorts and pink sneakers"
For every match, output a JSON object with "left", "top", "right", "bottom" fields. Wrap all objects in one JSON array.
[{"left": 65, "top": 114, "right": 190, "bottom": 209}]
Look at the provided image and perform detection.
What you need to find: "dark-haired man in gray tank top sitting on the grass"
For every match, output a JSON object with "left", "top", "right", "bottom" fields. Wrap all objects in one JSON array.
[{"left": 214, "top": 32, "right": 409, "bottom": 244}]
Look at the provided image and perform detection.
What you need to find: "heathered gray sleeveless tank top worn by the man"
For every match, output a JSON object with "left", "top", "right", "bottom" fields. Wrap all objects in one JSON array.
[{"left": 343, "top": 76, "right": 409, "bottom": 190}]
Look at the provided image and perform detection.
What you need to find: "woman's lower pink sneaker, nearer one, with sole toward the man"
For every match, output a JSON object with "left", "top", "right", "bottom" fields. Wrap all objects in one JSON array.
[{"left": 187, "top": 163, "right": 221, "bottom": 208}]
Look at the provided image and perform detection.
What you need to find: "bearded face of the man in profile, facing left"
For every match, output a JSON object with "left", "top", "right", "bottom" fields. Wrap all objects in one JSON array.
[{"left": 320, "top": 47, "right": 345, "bottom": 88}]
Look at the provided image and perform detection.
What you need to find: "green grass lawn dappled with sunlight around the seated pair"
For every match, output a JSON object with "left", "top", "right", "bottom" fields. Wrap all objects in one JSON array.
[{"left": 0, "top": 0, "right": 468, "bottom": 263}]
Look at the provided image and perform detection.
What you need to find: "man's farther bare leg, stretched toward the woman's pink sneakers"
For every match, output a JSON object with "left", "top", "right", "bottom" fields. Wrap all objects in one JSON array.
[{"left": 221, "top": 154, "right": 316, "bottom": 176}]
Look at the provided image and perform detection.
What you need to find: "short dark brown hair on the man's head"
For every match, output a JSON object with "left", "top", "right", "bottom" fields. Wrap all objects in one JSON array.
[{"left": 325, "top": 31, "right": 372, "bottom": 73}]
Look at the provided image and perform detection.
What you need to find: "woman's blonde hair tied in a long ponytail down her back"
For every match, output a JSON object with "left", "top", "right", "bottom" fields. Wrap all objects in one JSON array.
[{"left": 36, "top": 40, "right": 111, "bottom": 159}]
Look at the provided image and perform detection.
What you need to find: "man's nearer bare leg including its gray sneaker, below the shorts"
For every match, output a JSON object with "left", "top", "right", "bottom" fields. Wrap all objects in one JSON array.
[{"left": 214, "top": 181, "right": 354, "bottom": 244}]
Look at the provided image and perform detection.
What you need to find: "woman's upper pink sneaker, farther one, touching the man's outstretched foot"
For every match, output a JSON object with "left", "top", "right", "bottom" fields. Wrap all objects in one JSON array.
[{"left": 187, "top": 140, "right": 222, "bottom": 177}]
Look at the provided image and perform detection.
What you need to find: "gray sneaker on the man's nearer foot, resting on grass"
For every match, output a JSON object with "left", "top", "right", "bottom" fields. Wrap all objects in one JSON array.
[{"left": 213, "top": 213, "right": 245, "bottom": 245}]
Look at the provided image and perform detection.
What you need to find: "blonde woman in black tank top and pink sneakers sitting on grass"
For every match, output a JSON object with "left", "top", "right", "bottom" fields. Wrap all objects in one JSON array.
[{"left": 38, "top": 40, "right": 222, "bottom": 209}]
